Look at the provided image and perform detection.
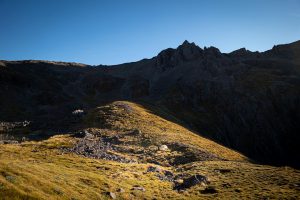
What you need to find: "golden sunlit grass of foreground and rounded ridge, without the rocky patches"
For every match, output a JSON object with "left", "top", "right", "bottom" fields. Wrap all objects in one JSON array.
[{"left": 0, "top": 102, "right": 300, "bottom": 199}]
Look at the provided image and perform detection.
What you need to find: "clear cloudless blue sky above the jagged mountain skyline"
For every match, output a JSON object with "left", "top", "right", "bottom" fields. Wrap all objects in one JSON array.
[{"left": 0, "top": 0, "right": 300, "bottom": 65}]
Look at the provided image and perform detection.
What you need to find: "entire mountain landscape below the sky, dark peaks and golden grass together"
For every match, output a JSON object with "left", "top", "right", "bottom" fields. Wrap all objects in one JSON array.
[{"left": 0, "top": 41, "right": 300, "bottom": 200}]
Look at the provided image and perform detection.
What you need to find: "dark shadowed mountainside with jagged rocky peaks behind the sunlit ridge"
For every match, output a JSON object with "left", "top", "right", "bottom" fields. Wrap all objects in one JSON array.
[{"left": 0, "top": 41, "right": 300, "bottom": 167}]
